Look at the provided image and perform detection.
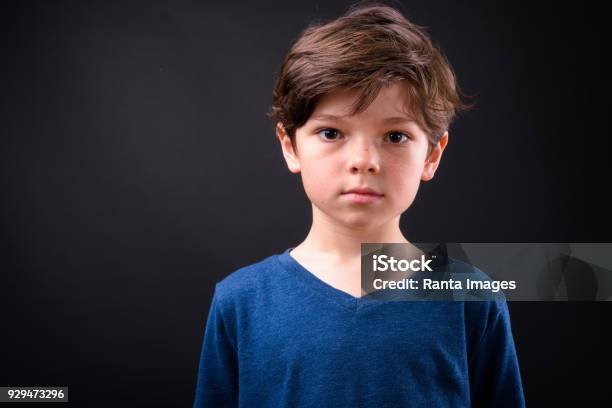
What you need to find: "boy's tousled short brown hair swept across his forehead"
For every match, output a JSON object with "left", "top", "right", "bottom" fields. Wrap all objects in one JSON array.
[{"left": 268, "top": 2, "right": 469, "bottom": 145}]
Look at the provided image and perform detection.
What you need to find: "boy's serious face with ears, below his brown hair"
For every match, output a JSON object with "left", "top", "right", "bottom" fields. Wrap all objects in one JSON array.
[{"left": 277, "top": 82, "right": 448, "bottom": 229}]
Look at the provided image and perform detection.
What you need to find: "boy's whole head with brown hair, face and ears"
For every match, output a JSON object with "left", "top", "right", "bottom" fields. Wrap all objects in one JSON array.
[{"left": 270, "top": 4, "right": 465, "bottom": 230}]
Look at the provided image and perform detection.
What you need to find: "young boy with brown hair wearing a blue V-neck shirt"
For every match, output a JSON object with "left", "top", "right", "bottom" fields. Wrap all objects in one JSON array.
[{"left": 194, "top": 4, "right": 524, "bottom": 407}]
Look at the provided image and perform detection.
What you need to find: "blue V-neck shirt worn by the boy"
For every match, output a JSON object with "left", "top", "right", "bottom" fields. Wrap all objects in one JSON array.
[{"left": 194, "top": 248, "right": 525, "bottom": 408}]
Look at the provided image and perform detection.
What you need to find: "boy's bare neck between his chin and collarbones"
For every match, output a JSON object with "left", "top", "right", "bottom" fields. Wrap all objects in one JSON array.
[{"left": 296, "top": 205, "right": 409, "bottom": 260}]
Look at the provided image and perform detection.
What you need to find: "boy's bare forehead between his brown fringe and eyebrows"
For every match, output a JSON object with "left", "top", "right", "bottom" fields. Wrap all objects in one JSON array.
[{"left": 311, "top": 81, "right": 414, "bottom": 120}]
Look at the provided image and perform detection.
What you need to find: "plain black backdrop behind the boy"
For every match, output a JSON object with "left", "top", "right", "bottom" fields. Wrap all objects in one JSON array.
[{"left": 0, "top": 1, "right": 612, "bottom": 406}]
